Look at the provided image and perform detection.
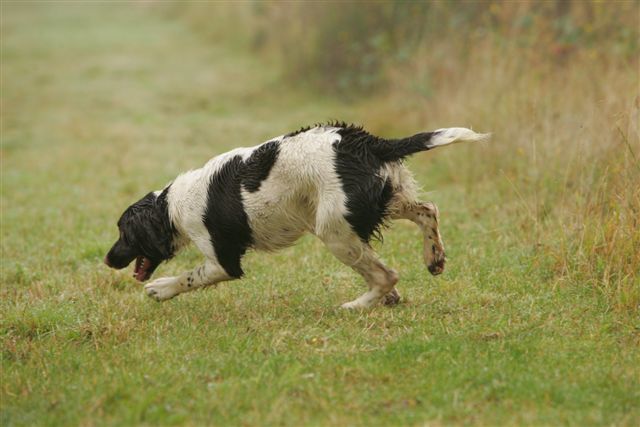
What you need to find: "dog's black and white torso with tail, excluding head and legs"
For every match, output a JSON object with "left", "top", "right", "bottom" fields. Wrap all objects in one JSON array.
[{"left": 169, "top": 124, "right": 490, "bottom": 251}]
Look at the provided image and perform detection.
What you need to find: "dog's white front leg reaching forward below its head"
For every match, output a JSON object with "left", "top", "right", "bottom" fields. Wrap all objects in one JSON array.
[{"left": 144, "top": 261, "right": 231, "bottom": 301}]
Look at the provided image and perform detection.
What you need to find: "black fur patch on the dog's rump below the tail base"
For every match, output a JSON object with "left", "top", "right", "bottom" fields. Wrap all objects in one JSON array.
[{"left": 333, "top": 127, "right": 393, "bottom": 242}]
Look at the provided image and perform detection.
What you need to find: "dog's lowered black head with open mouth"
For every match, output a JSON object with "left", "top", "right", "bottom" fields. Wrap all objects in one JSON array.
[{"left": 104, "top": 193, "right": 174, "bottom": 282}]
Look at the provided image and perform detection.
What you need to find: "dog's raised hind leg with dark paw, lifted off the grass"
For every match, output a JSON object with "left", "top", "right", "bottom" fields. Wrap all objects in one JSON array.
[{"left": 392, "top": 201, "right": 445, "bottom": 276}]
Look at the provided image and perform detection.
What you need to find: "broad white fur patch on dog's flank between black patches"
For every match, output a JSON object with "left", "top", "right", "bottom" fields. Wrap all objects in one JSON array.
[{"left": 242, "top": 127, "right": 346, "bottom": 250}]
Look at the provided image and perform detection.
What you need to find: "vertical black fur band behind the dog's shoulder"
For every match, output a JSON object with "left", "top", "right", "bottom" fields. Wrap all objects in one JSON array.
[{"left": 203, "top": 156, "right": 259, "bottom": 278}]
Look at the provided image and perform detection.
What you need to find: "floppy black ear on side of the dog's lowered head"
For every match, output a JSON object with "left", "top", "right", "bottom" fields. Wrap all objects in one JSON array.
[{"left": 122, "top": 190, "right": 174, "bottom": 263}]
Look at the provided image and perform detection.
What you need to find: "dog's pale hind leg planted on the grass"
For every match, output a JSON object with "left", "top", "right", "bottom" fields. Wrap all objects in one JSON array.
[{"left": 321, "top": 230, "right": 400, "bottom": 308}]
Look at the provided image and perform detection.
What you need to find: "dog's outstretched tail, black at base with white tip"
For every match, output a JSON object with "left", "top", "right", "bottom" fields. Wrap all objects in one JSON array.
[{"left": 372, "top": 128, "right": 491, "bottom": 162}]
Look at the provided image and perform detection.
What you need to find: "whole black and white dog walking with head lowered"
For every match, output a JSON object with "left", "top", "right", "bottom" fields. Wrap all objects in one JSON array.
[{"left": 105, "top": 123, "right": 489, "bottom": 308}]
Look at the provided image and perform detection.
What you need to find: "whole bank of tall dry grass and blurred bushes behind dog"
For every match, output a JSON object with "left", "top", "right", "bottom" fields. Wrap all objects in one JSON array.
[{"left": 170, "top": 0, "right": 640, "bottom": 313}]
